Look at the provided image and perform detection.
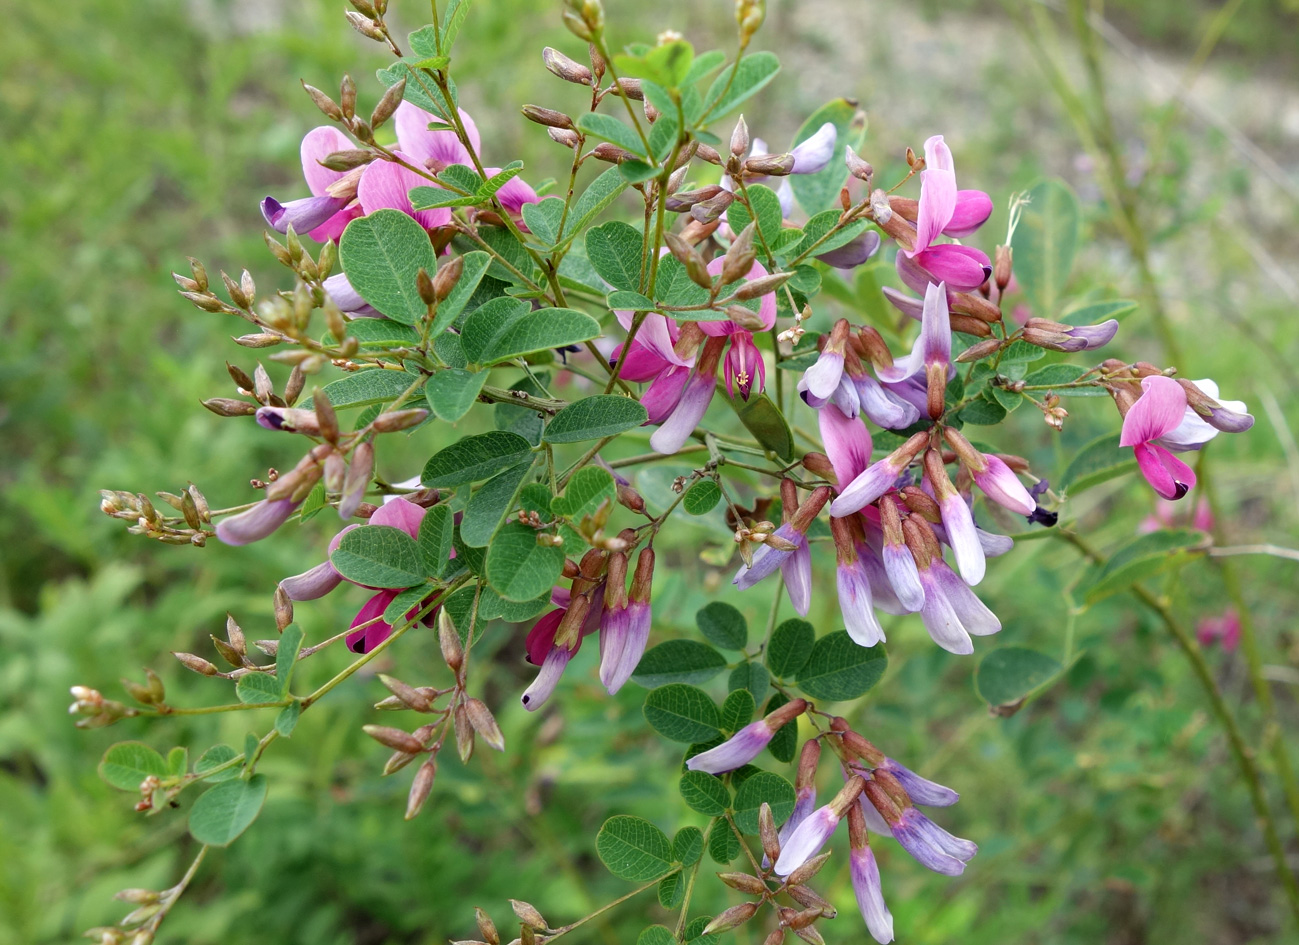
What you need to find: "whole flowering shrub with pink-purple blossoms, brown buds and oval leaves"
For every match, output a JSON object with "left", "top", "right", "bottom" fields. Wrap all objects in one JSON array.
[{"left": 73, "top": 0, "right": 1252, "bottom": 945}]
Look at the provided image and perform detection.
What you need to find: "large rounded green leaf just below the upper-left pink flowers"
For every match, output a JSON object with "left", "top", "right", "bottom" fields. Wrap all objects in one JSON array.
[{"left": 338, "top": 209, "right": 438, "bottom": 325}]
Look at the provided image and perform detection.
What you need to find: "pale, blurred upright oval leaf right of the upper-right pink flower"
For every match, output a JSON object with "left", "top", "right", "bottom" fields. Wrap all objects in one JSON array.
[{"left": 1011, "top": 179, "right": 1082, "bottom": 318}]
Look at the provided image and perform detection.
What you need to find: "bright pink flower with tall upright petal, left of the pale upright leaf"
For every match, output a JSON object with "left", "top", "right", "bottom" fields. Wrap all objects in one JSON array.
[{"left": 899, "top": 135, "right": 992, "bottom": 291}]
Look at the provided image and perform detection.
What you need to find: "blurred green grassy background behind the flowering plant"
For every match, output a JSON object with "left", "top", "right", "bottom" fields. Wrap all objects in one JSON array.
[{"left": 0, "top": 0, "right": 1299, "bottom": 945}]
